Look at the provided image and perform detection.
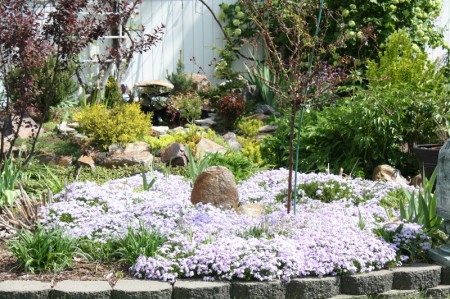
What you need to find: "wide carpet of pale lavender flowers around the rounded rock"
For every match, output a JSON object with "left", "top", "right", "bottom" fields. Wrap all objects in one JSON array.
[{"left": 37, "top": 169, "right": 429, "bottom": 281}]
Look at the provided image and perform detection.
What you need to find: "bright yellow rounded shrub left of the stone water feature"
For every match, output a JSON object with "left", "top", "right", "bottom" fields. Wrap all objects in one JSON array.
[{"left": 74, "top": 103, "right": 151, "bottom": 149}]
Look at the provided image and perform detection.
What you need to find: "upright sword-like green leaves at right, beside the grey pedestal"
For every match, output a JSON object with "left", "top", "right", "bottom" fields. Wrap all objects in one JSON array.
[{"left": 400, "top": 168, "right": 445, "bottom": 245}]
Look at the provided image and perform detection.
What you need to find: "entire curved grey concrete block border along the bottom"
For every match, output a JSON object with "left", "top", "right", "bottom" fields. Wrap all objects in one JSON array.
[{"left": 0, "top": 264, "right": 450, "bottom": 299}]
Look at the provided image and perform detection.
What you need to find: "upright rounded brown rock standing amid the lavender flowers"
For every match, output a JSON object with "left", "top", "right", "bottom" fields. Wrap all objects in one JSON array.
[{"left": 191, "top": 166, "right": 239, "bottom": 209}]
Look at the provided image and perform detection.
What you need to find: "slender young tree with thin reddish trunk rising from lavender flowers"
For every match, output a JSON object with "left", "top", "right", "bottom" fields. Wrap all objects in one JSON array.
[{"left": 238, "top": 0, "right": 346, "bottom": 213}]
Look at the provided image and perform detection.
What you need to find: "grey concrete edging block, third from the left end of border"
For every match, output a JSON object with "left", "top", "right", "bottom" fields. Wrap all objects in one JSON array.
[{"left": 111, "top": 280, "right": 172, "bottom": 299}]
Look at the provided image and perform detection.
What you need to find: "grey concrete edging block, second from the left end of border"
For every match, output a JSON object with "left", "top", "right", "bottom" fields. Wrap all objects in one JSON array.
[{"left": 49, "top": 280, "right": 111, "bottom": 299}]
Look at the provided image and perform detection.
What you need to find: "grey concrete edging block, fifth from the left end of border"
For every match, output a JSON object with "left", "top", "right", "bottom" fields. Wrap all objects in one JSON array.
[{"left": 231, "top": 281, "right": 286, "bottom": 299}]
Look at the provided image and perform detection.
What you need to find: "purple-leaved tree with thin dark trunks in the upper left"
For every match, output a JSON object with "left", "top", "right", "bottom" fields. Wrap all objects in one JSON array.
[{"left": 0, "top": 0, "right": 164, "bottom": 166}]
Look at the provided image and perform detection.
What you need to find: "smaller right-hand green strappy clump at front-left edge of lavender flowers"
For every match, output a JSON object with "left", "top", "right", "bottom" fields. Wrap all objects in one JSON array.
[{"left": 114, "top": 222, "right": 167, "bottom": 266}]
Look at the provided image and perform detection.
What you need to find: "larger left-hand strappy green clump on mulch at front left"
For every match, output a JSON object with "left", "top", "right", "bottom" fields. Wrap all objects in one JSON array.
[{"left": 8, "top": 225, "right": 76, "bottom": 273}]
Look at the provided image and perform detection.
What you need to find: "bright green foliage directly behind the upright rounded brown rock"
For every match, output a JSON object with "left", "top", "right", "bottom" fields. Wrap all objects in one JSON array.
[{"left": 208, "top": 151, "right": 256, "bottom": 183}]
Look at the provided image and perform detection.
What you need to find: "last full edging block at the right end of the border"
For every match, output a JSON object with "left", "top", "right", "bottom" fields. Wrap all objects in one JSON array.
[{"left": 392, "top": 264, "right": 441, "bottom": 290}]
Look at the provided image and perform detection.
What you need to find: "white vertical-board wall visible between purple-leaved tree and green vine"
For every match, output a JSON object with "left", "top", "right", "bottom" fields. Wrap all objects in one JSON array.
[{"left": 124, "top": 0, "right": 234, "bottom": 86}]
